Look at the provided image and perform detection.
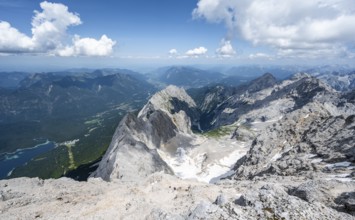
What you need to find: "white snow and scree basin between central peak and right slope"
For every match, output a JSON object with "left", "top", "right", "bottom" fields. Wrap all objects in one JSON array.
[{"left": 158, "top": 136, "right": 247, "bottom": 183}]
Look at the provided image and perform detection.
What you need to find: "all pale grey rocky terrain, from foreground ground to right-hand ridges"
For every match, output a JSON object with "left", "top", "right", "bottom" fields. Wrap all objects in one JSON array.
[{"left": 0, "top": 74, "right": 355, "bottom": 220}]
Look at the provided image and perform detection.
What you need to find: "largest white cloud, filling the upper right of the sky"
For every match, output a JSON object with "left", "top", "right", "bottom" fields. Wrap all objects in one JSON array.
[{"left": 193, "top": 0, "right": 355, "bottom": 58}]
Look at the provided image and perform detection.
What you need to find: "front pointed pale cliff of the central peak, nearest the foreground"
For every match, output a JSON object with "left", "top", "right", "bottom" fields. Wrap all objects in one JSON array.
[{"left": 91, "top": 114, "right": 171, "bottom": 181}]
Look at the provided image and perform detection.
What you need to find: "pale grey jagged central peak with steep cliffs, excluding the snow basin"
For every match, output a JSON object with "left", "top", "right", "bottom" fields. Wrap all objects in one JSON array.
[{"left": 92, "top": 86, "right": 195, "bottom": 181}]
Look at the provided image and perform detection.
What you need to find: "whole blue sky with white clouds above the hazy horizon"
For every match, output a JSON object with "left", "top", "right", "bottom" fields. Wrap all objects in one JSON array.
[{"left": 0, "top": 0, "right": 355, "bottom": 70}]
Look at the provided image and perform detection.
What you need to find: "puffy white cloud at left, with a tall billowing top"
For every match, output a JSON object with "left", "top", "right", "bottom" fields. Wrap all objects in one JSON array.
[{"left": 0, "top": 1, "right": 116, "bottom": 56}]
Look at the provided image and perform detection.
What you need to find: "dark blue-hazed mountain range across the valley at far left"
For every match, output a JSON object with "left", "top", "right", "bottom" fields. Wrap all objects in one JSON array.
[{"left": 0, "top": 72, "right": 154, "bottom": 123}]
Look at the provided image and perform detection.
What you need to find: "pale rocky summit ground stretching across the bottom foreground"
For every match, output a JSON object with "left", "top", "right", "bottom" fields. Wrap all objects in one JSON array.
[{"left": 0, "top": 173, "right": 355, "bottom": 220}]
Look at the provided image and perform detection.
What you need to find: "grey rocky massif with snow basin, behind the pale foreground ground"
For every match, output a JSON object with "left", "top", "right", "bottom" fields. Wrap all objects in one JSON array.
[{"left": 92, "top": 74, "right": 354, "bottom": 183}]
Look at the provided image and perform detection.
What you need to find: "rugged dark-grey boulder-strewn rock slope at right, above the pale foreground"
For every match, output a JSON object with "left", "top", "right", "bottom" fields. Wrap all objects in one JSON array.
[{"left": 235, "top": 103, "right": 355, "bottom": 178}]
